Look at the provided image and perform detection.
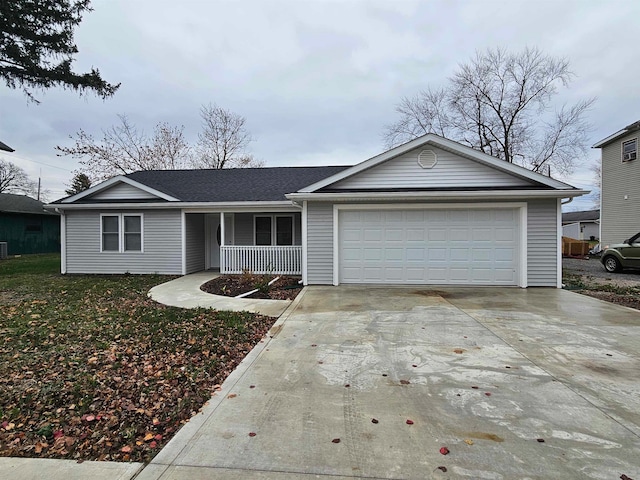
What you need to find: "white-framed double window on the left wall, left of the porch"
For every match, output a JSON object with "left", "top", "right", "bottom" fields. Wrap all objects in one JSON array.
[{"left": 100, "top": 213, "right": 143, "bottom": 252}]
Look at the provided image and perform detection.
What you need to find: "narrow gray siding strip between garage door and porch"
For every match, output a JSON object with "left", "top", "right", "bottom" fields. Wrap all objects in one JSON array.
[{"left": 307, "top": 202, "right": 333, "bottom": 285}]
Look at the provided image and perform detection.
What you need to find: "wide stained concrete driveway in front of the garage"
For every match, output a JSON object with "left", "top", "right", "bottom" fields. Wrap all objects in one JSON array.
[{"left": 137, "top": 287, "right": 640, "bottom": 480}]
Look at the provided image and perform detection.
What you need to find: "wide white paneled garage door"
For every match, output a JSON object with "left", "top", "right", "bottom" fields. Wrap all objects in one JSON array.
[{"left": 338, "top": 208, "right": 520, "bottom": 285}]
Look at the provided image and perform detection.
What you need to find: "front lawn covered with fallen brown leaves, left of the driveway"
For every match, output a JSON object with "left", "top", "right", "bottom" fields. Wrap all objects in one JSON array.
[{"left": 0, "top": 255, "right": 275, "bottom": 462}]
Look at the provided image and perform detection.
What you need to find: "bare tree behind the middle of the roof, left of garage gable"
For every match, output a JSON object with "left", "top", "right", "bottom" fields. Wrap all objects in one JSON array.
[{"left": 194, "top": 104, "right": 263, "bottom": 168}]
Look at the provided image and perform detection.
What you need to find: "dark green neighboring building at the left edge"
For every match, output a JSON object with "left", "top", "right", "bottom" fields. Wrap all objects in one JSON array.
[{"left": 0, "top": 193, "right": 60, "bottom": 255}]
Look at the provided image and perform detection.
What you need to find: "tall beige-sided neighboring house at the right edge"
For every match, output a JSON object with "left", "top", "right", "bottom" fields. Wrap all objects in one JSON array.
[{"left": 593, "top": 121, "right": 640, "bottom": 245}]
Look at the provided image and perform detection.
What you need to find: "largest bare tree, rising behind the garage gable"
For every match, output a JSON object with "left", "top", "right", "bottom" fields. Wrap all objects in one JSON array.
[{"left": 384, "top": 48, "right": 595, "bottom": 175}]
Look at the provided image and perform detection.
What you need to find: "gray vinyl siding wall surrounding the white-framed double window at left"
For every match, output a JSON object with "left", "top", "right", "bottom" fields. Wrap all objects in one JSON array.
[{"left": 65, "top": 210, "right": 182, "bottom": 275}]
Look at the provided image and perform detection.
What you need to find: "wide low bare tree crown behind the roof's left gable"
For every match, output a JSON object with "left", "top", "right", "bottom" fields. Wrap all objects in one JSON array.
[{"left": 56, "top": 115, "right": 190, "bottom": 181}]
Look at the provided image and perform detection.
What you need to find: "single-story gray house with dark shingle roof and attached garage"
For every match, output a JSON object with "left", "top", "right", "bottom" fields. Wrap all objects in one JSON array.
[{"left": 47, "top": 134, "right": 586, "bottom": 287}]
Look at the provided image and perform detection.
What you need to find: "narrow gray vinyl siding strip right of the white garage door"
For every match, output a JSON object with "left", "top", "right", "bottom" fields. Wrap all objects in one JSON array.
[{"left": 527, "top": 198, "right": 559, "bottom": 287}]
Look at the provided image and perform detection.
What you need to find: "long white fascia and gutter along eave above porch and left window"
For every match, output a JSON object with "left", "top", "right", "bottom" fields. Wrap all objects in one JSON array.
[{"left": 51, "top": 200, "right": 302, "bottom": 213}]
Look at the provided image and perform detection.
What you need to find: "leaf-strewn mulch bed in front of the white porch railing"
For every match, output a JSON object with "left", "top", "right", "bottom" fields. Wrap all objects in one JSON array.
[{"left": 200, "top": 274, "right": 302, "bottom": 300}]
